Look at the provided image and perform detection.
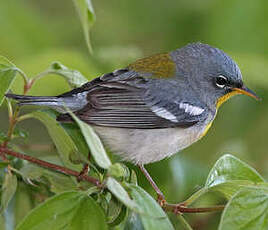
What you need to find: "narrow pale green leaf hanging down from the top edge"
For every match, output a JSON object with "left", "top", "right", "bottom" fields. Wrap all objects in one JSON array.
[{"left": 73, "top": 0, "right": 96, "bottom": 53}]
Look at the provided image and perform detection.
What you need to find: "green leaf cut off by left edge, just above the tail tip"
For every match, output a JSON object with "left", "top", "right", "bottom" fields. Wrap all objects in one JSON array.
[{"left": 0, "top": 56, "right": 17, "bottom": 106}]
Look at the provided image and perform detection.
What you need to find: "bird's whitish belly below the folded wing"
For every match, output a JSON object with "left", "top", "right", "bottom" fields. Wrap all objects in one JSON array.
[{"left": 94, "top": 125, "right": 205, "bottom": 164}]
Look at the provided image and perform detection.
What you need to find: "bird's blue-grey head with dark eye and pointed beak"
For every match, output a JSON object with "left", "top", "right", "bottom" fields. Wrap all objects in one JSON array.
[{"left": 171, "top": 43, "right": 257, "bottom": 108}]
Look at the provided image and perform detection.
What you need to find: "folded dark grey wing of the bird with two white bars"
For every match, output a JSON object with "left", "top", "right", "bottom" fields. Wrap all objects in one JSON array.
[{"left": 58, "top": 69, "right": 207, "bottom": 129}]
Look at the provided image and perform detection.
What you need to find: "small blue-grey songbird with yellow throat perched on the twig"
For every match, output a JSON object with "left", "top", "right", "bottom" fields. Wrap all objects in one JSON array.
[{"left": 6, "top": 42, "right": 260, "bottom": 201}]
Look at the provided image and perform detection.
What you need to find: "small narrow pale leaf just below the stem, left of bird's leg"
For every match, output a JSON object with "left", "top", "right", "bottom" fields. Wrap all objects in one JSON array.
[{"left": 106, "top": 177, "right": 138, "bottom": 211}]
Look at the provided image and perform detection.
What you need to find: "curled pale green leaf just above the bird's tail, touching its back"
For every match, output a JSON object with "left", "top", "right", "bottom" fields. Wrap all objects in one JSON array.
[{"left": 48, "top": 62, "right": 88, "bottom": 88}]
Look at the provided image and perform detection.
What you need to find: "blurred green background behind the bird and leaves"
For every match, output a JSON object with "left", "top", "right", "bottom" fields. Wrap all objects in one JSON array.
[{"left": 0, "top": 0, "right": 268, "bottom": 229}]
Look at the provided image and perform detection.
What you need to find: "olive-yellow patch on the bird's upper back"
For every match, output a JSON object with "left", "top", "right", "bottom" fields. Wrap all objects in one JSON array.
[{"left": 128, "top": 53, "right": 175, "bottom": 78}]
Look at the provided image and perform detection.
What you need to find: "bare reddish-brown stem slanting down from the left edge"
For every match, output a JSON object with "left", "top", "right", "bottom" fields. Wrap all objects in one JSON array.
[{"left": 0, "top": 147, "right": 102, "bottom": 188}]
